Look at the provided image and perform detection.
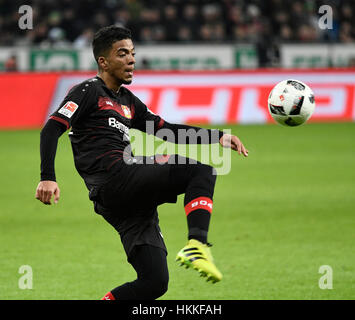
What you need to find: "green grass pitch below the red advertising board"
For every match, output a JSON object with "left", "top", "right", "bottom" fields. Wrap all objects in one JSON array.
[{"left": 0, "top": 123, "right": 355, "bottom": 300}]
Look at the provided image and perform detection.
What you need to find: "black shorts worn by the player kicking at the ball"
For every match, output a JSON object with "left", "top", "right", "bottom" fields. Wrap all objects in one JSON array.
[{"left": 89, "top": 155, "right": 197, "bottom": 260}]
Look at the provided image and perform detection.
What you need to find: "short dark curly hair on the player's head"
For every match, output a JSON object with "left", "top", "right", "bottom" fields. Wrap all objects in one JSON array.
[{"left": 92, "top": 25, "right": 132, "bottom": 62}]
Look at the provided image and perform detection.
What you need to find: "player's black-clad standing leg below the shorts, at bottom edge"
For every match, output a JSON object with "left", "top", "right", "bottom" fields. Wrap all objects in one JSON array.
[{"left": 102, "top": 245, "right": 169, "bottom": 300}]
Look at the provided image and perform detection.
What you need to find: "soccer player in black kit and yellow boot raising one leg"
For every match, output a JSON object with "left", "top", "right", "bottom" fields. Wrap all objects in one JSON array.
[{"left": 36, "top": 26, "right": 248, "bottom": 300}]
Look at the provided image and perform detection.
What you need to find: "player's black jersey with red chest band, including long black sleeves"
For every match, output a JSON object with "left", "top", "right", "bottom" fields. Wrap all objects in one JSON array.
[{"left": 40, "top": 76, "right": 223, "bottom": 186}]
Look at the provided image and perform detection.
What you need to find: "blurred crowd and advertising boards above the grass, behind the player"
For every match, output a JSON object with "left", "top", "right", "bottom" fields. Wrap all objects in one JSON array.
[{"left": 0, "top": 0, "right": 355, "bottom": 128}]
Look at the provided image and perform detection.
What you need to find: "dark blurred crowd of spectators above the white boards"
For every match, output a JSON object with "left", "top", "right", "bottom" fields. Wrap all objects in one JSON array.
[{"left": 0, "top": 0, "right": 355, "bottom": 69}]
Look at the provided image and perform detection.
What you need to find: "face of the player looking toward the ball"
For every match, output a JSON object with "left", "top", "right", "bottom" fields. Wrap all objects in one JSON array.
[{"left": 106, "top": 39, "right": 136, "bottom": 84}]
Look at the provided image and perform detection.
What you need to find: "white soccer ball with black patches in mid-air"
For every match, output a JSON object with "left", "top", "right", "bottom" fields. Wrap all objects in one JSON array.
[{"left": 268, "top": 79, "right": 315, "bottom": 127}]
